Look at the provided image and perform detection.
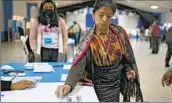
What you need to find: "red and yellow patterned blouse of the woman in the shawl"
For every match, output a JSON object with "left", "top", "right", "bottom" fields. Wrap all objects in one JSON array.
[{"left": 90, "top": 32, "right": 122, "bottom": 66}]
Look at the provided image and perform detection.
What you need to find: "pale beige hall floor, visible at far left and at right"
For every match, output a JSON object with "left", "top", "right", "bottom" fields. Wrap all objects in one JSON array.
[{"left": 1, "top": 40, "right": 172, "bottom": 102}]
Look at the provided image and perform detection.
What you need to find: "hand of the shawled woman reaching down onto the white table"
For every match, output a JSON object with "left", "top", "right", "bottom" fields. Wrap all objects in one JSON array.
[{"left": 55, "top": 85, "right": 72, "bottom": 97}]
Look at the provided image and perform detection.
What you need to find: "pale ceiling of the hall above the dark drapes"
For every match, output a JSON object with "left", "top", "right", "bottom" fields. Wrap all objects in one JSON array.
[{"left": 23, "top": 0, "right": 172, "bottom": 12}]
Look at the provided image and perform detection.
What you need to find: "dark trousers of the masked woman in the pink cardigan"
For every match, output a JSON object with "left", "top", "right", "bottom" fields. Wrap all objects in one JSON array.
[{"left": 41, "top": 47, "right": 58, "bottom": 62}]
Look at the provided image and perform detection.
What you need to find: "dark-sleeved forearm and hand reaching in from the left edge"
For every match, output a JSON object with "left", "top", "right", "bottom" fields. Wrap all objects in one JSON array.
[{"left": 1, "top": 80, "right": 33, "bottom": 91}]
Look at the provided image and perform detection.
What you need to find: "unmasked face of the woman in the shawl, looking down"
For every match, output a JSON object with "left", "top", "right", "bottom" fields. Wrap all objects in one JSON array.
[{"left": 92, "top": 7, "right": 113, "bottom": 29}]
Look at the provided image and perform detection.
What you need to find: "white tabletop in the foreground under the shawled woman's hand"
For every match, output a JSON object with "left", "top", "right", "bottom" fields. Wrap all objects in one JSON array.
[{"left": 1, "top": 82, "right": 99, "bottom": 103}]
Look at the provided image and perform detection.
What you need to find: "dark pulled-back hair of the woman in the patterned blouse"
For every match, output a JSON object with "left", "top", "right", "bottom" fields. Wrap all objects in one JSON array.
[{"left": 93, "top": 0, "right": 116, "bottom": 14}]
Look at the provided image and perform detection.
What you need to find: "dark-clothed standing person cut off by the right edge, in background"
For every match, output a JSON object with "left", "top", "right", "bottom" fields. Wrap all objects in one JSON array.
[{"left": 165, "top": 26, "right": 172, "bottom": 67}]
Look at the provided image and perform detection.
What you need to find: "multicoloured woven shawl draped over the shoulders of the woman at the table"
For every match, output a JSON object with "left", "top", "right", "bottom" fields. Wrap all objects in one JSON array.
[{"left": 71, "top": 25, "right": 143, "bottom": 102}]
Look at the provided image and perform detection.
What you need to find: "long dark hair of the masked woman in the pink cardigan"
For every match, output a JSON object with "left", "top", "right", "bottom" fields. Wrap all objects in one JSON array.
[{"left": 38, "top": 0, "right": 59, "bottom": 27}]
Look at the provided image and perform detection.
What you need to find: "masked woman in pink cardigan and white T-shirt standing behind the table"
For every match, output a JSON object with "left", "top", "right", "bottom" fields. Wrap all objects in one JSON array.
[{"left": 29, "top": 0, "right": 68, "bottom": 62}]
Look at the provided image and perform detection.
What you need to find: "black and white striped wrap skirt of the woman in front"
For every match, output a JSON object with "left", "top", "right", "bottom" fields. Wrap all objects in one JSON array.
[{"left": 94, "top": 65, "right": 122, "bottom": 102}]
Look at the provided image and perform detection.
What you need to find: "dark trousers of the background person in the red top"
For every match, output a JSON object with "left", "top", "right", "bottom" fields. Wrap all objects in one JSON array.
[{"left": 152, "top": 37, "right": 160, "bottom": 53}]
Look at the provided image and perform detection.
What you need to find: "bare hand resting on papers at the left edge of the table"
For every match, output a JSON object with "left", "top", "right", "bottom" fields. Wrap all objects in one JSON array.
[{"left": 11, "top": 80, "right": 33, "bottom": 90}]
